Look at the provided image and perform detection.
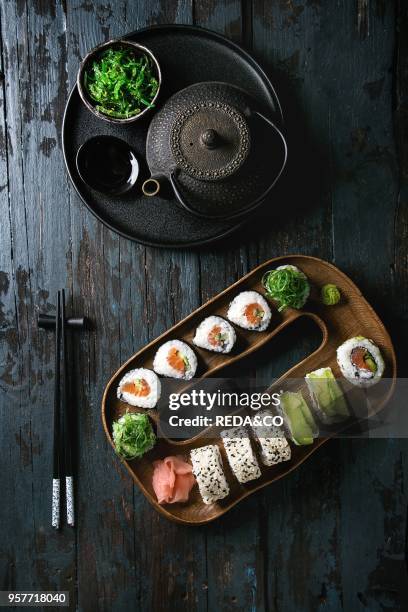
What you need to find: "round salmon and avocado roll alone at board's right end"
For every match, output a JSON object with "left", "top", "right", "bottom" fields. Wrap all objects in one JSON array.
[{"left": 337, "top": 336, "right": 385, "bottom": 387}]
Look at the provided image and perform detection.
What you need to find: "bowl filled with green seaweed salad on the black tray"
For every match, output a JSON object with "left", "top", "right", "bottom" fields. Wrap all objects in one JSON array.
[{"left": 77, "top": 40, "right": 161, "bottom": 123}]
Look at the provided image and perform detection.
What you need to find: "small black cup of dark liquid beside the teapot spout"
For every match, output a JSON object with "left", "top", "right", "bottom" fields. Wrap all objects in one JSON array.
[{"left": 76, "top": 136, "right": 139, "bottom": 195}]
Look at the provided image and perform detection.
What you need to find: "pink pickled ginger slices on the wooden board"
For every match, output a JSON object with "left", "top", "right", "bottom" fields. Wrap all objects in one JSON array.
[{"left": 152, "top": 456, "right": 195, "bottom": 504}]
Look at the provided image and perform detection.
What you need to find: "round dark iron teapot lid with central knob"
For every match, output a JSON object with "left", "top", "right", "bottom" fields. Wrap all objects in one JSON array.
[{"left": 170, "top": 96, "right": 250, "bottom": 181}]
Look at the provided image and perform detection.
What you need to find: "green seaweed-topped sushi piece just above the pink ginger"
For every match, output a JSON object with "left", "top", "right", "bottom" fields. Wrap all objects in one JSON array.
[{"left": 113, "top": 413, "right": 156, "bottom": 461}]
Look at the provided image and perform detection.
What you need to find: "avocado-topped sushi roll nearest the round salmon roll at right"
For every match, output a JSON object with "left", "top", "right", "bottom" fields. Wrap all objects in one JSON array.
[{"left": 305, "top": 368, "right": 350, "bottom": 425}]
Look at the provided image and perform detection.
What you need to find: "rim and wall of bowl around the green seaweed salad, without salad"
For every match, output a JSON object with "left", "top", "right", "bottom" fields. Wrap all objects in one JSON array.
[{"left": 77, "top": 39, "right": 162, "bottom": 125}]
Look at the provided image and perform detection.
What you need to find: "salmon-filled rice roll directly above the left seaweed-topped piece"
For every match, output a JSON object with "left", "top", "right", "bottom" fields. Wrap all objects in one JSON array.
[{"left": 117, "top": 368, "right": 161, "bottom": 408}]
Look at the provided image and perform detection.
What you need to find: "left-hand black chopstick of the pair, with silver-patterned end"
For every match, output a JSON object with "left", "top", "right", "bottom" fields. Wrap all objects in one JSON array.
[{"left": 51, "top": 291, "right": 61, "bottom": 529}]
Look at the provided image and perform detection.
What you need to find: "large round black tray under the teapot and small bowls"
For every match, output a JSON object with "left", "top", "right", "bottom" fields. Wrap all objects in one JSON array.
[{"left": 62, "top": 25, "right": 282, "bottom": 248}]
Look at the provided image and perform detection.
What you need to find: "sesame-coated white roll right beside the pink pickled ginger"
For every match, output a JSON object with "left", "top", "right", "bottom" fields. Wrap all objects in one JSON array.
[{"left": 190, "top": 444, "right": 229, "bottom": 504}]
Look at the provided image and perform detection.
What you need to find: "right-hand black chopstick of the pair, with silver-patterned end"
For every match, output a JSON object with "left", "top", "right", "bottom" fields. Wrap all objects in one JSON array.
[{"left": 60, "top": 289, "right": 75, "bottom": 527}]
